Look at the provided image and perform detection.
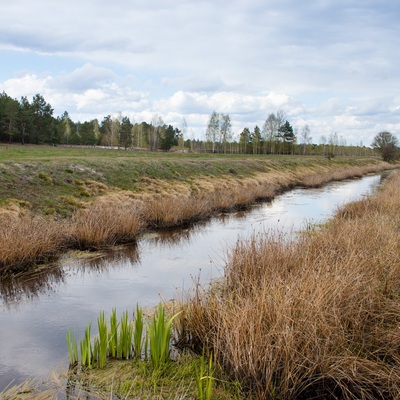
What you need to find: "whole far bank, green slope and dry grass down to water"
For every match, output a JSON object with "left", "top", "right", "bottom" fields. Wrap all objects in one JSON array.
[{"left": 0, "top": 146, "right": 393, "bottom": 275}]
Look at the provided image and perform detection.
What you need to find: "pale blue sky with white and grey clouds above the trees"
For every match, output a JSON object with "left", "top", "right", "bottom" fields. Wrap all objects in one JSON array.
[{"left": 0, "top": 0, "right": 400, "bottom": 145}]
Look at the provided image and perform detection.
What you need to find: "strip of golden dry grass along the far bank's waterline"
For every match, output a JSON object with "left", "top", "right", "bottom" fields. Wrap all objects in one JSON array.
[{"left": 0, "top": 164, "right": 396, "bottom": 273}]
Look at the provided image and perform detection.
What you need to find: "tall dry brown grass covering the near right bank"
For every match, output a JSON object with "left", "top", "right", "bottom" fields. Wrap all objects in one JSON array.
[{"left": 181, "top": 170, "right": 400, "bottom": 399}]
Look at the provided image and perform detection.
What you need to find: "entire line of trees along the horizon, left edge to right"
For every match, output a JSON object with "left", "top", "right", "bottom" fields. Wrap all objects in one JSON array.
[{"left": 0, "top": 92, "right": 398, "bottom": 160}]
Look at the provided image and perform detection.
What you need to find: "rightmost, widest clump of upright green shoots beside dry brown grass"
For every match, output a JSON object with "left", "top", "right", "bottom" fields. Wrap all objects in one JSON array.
[{"left": 147, "top": 303, "right": 178, "bottom": 369}]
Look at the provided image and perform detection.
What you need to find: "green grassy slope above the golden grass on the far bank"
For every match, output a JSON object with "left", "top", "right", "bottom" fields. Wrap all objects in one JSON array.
[{"left": 0, "top": 145, "right": 394, "bottom": 216}]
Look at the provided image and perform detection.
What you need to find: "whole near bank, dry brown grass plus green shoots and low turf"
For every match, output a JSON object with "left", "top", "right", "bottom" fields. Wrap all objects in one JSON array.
[{"left": 1, "top": 155, "right": 400, "bottom": 400}]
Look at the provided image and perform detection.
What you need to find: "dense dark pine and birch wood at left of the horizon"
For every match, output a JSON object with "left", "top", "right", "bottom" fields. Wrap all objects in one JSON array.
[{"left": 0, "top": 92, "right": 181, "bottom": 151}]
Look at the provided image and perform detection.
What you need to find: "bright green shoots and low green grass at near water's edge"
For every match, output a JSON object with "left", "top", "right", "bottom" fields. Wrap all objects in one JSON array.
[{"left": 66, "top": 304, "right": 240, "bottom": 400}]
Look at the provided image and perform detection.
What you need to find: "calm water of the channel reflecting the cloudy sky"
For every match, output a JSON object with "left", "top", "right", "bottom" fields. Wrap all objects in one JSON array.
[{"left": 0, "top": 175, "right": 382, "bottom": 391}]
